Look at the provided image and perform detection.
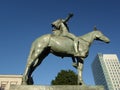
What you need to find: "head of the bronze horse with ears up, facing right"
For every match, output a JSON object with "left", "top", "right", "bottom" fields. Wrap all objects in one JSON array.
[{"left": 94, "top": 27, "right": 110, "bottom": 43}]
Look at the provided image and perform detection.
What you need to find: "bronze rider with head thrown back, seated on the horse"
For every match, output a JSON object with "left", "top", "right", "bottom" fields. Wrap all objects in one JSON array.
[{"left": 52, "top": 14, "right": 79, "bottom": 56}]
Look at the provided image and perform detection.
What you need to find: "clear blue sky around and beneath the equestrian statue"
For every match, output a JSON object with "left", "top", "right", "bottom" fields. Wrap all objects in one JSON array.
[{"left": 0, "top": 0, "right": 120, "bottom": 85}]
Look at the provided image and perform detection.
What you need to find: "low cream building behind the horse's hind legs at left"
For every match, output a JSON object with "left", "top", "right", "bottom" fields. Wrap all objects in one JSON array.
[{"left": 0, "top": 75, "right": 22, "bottom": 90}]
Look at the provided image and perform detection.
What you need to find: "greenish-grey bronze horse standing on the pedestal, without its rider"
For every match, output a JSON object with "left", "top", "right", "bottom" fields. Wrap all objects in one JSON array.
[{"left": 22, "top": 14, "right": 110, "bottom": 85}]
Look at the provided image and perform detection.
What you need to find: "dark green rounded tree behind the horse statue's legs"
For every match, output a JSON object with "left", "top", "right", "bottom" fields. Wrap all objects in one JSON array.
[{"left": 51, "top": 70, "right": 77, "bottom": 85}]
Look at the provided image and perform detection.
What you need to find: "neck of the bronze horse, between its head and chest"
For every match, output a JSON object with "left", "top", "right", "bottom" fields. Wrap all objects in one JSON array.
[{"left": 80, "top": 31, "right": 96, "bottom": 44}]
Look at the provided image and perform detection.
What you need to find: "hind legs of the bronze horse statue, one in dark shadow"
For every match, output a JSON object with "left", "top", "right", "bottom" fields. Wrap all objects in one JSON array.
[{"left": 23, "top": 45, "right": 48, "bottom": 84}]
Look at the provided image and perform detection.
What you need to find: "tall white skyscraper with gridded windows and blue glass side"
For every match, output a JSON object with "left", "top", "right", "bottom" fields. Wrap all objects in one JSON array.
[{"left": 92, "top": 54, "right": 120, "bottom": 90}]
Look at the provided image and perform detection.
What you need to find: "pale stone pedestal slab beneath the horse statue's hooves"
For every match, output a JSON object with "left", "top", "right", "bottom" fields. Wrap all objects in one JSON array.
[{"left": 10, "top": 85, "right": 104, "bottom": 90}]
